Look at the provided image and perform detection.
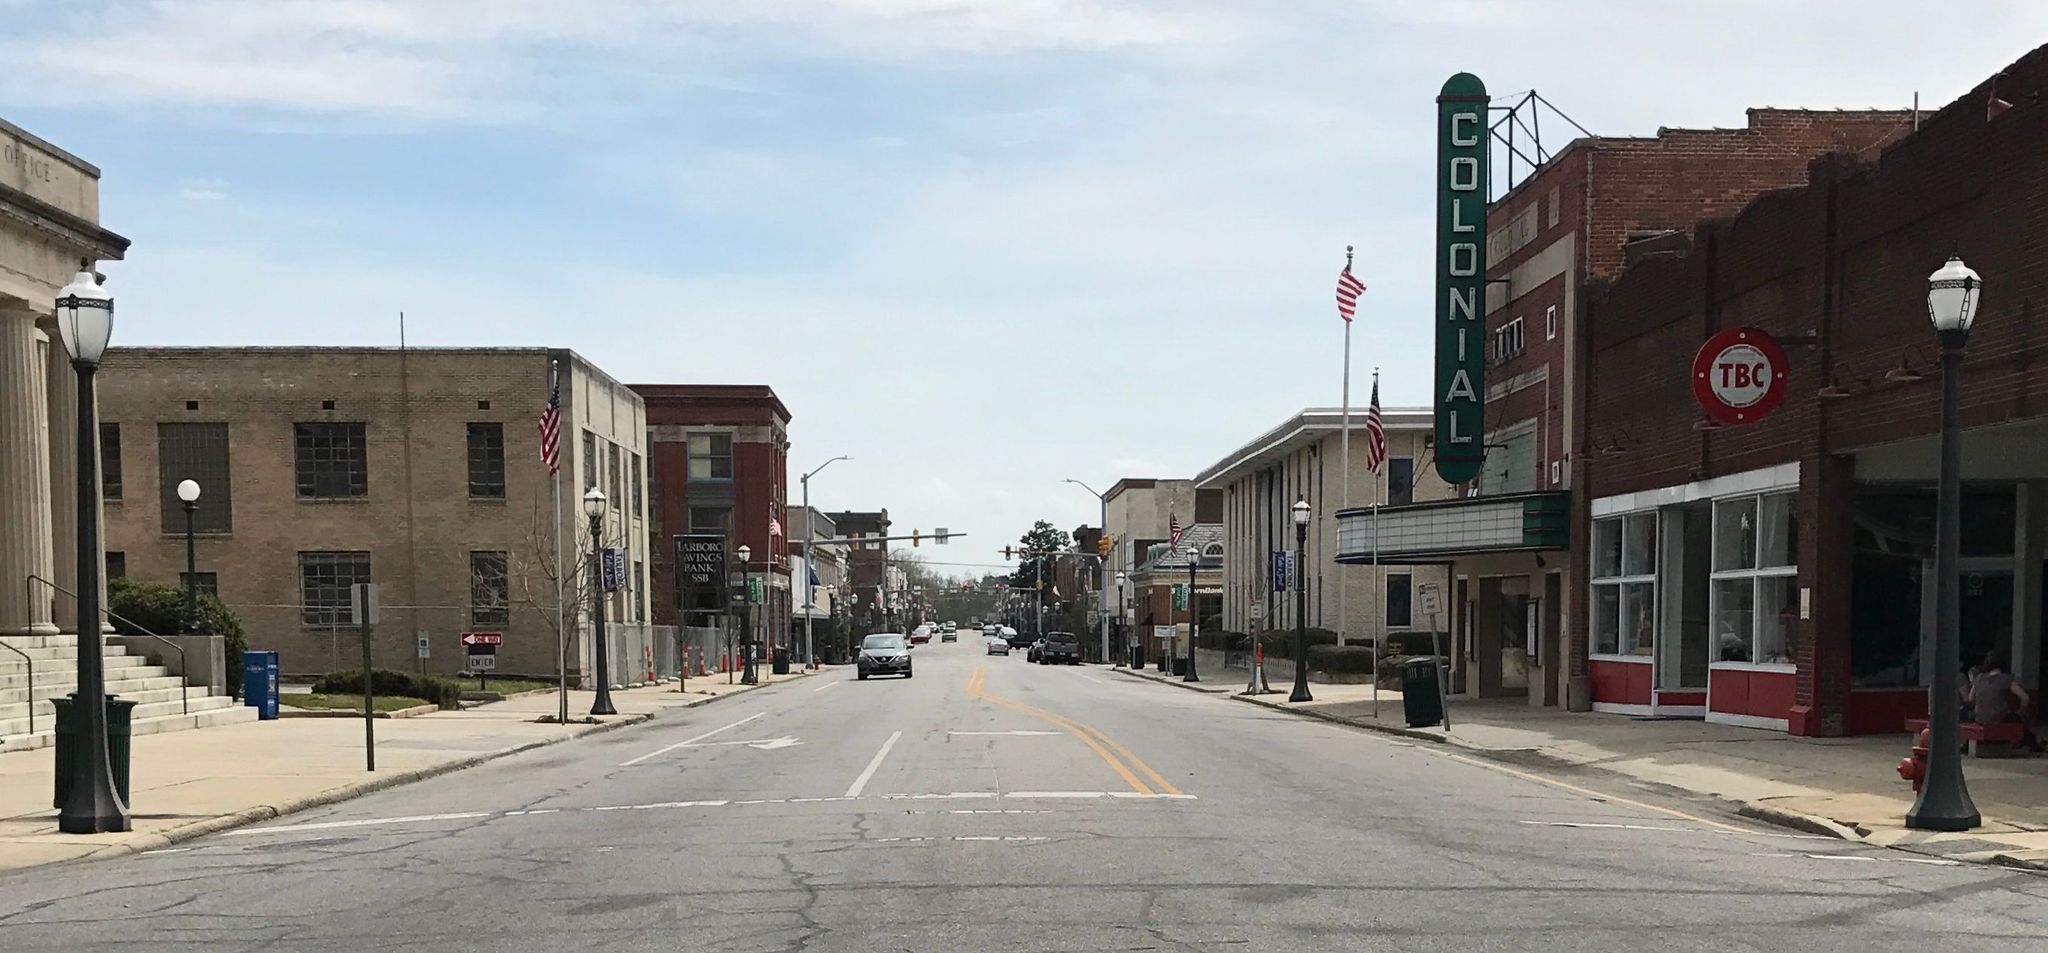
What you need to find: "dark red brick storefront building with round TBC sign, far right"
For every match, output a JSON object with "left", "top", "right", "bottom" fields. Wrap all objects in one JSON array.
[{"left": 1571, "top": 47, "right": 2048, "bottom": 736}]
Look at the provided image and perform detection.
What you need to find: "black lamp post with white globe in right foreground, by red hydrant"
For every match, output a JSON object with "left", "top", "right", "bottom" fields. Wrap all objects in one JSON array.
[{"left": 1907, "top": 256, "right": 1982, "bottom": 830}]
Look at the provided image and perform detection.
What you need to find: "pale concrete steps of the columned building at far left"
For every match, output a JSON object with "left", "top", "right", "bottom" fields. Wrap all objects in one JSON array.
[{"left": 0, "top": 635, "right": 256, "bottom": 750}]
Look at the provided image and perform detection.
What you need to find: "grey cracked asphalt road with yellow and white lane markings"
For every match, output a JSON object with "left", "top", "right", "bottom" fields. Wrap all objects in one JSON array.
[{"left": 0, "top": 633, "right": 2048, "bottom": 953}]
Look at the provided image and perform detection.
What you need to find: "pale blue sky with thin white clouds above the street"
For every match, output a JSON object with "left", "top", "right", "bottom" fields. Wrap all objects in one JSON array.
[{"left": 0, "top": 0, "right": 2048, "bottom": 574}]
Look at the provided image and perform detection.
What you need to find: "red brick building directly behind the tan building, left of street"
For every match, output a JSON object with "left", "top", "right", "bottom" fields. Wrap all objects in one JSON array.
[{"left": 633, "top": 383, "right": 793, "bottom": 646}]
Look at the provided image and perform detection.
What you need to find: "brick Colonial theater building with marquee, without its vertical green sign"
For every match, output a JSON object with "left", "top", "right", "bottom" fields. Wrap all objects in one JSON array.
[{"left": 1339, "top": 109, "right": 1913, "bottom": 715}]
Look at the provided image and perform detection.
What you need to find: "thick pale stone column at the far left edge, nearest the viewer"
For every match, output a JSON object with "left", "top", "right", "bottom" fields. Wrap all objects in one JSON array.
[{"left": 0, "top": 309, "right": 57, "bottom": 635}]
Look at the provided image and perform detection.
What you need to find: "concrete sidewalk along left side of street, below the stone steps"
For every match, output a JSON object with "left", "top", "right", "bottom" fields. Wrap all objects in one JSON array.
[{"left": 0, "top": 672, "right": 805, "bottom": 869}]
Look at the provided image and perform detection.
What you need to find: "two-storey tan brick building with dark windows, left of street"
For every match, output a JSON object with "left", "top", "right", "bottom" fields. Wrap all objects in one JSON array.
[{"left": 100, "top": 348, "right": 649, "bottom": 674}]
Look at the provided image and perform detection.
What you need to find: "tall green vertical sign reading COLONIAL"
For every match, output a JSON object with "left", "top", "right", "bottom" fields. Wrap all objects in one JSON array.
[{"left": 1436, "top": 74, "right": 1489, "bottom": 484}]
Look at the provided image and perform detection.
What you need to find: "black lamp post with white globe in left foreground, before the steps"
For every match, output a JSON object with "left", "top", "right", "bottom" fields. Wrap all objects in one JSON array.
[{"left": 55, "top": 262, "right": 129, "bottom": 834}]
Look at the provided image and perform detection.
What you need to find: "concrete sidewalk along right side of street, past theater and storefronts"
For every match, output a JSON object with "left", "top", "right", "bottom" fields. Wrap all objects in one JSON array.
[{"left": 1126, "top": 662, "right": 2048, "bottom": 869}]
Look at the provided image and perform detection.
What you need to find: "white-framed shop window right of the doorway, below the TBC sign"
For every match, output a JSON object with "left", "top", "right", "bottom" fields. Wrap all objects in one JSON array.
[{"left": 1708, "top": 494, "right": 1798, "bottom": 666}]
